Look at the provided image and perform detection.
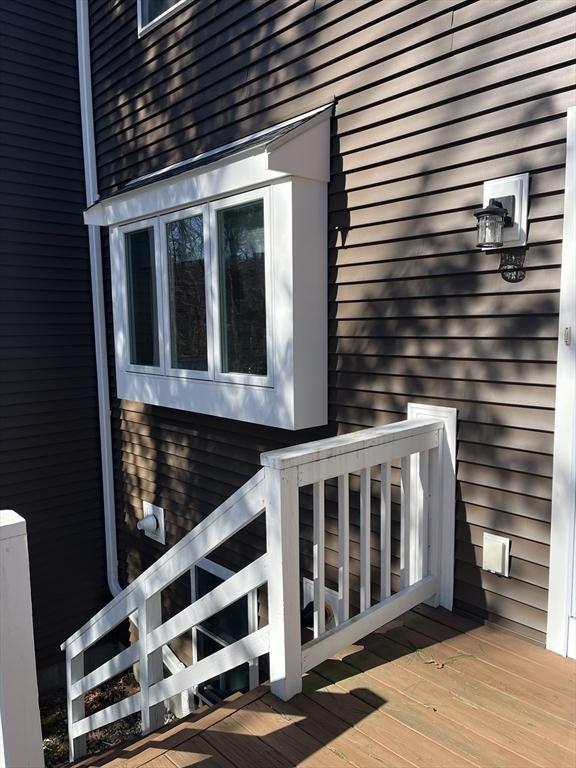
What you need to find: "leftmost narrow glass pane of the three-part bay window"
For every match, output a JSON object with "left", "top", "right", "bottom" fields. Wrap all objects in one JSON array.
[{"left": 125, "top": 228, "right": 158, "bottom": 365}]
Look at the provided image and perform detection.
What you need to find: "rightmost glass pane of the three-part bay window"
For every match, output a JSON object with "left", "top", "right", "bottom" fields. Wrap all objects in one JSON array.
[{"left": 218, "top": 200, "right": 267, "bottom": 376}]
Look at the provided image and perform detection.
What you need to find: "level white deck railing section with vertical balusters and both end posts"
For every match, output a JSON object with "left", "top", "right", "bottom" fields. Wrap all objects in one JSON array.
[{"left": 262, "top": 404, "right": 456, "bottom": 699}]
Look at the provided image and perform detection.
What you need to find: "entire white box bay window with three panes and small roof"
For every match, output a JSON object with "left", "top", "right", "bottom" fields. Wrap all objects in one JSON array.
[{"left": 85, "top": 103, "right": 329, "bottom": 429}]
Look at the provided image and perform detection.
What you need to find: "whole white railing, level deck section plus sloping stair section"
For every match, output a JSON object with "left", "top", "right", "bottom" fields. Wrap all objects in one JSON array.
[{"left": 62, "top": 405, "right": 456, "bottom": 759}]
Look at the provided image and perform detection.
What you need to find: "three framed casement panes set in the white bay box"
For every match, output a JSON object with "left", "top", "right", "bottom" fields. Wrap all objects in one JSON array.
[{"left": 119, "top": 191, "right": 272, "bottom": 386}]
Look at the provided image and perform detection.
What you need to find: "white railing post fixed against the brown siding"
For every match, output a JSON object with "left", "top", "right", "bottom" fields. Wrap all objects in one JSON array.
[{"left": 407, "top": 403, "right": 458, "bottom": 611}]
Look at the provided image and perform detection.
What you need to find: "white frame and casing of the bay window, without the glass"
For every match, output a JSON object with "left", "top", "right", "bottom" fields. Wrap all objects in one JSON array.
[{"left": 96, "top": 108, "right": 330, "bottom": 430}]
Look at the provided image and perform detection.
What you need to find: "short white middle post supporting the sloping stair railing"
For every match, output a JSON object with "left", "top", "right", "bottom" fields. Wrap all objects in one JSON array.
[{"left": 138, "top": 592, "right": 164, "bottom": 735}]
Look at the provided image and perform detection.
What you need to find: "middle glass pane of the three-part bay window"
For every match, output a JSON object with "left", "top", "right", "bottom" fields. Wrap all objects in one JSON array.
[{"left": 166, "top": 215, "right": 208, "bottom": 371}]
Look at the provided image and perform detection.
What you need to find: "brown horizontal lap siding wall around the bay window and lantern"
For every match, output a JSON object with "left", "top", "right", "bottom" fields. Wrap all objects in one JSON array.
[{"left": 90, "top": 0, "right": 575, "bottom": 641}]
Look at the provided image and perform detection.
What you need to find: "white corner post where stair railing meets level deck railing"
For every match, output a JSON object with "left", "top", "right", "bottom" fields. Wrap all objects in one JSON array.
[{"left": 262, "top": 462, "right": 302, "bottom": 701}]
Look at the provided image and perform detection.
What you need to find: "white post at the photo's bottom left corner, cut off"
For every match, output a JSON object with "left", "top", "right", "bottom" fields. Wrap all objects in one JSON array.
[{"left": 0, "top": 509, "right": 44, "bottom": 768}]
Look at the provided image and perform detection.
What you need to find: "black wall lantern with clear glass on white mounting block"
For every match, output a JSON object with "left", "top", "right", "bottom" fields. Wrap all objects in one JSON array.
[{"left": 474, "top": 173, "right": 529, "bottom": 250}]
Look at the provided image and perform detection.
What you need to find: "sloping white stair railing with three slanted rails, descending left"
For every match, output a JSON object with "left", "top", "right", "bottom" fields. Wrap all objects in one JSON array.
[{"left": 62, "top": 470, "right": 268, "bottom": 760}]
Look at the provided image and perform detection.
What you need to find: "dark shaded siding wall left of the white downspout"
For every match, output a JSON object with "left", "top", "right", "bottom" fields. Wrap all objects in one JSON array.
[{"left": 0, "top": 0, "right": 108, "bottom": 667}]
